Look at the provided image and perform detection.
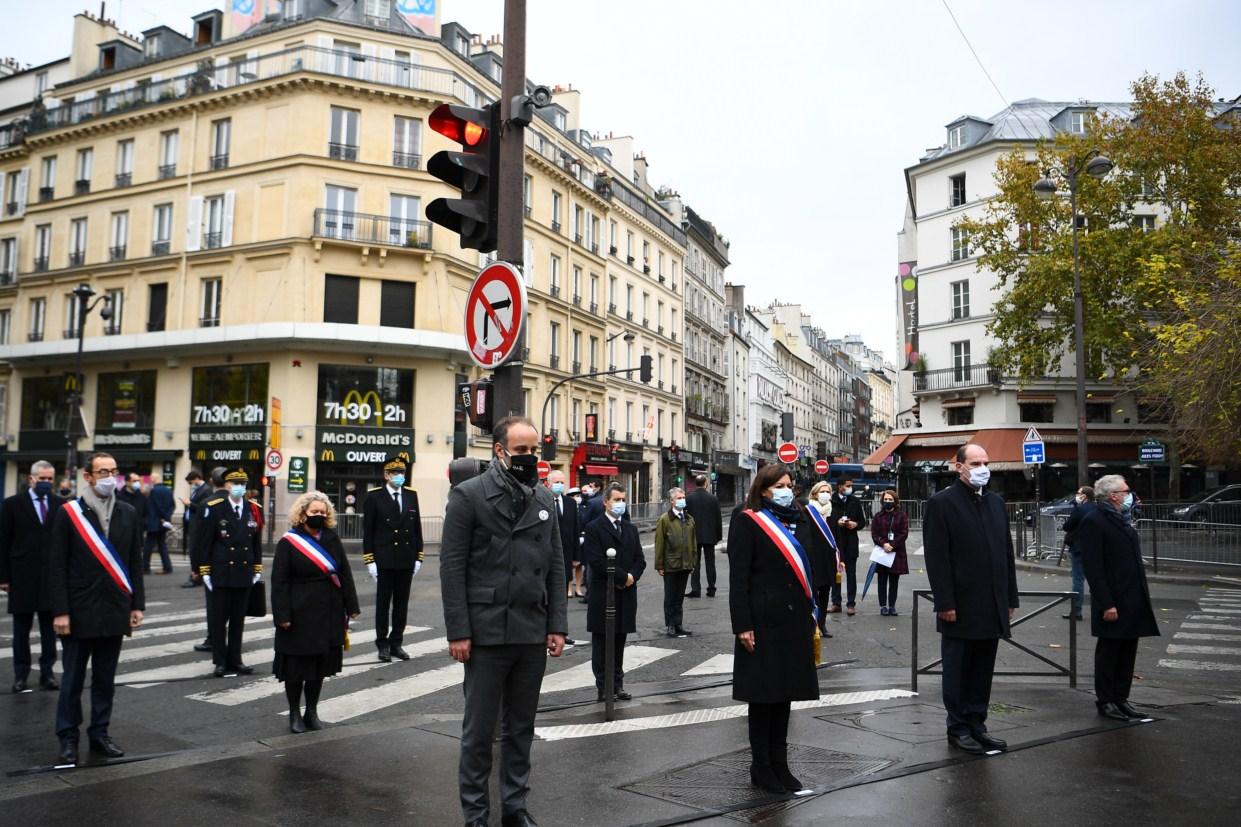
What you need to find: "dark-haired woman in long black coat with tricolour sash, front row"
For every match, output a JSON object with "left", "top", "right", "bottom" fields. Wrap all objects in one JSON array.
[{"left": 728, "top": 464, "right": 819, "bottom": 793}]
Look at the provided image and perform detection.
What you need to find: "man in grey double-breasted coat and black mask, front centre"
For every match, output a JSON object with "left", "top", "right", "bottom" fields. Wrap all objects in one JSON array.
[{"left": 439, "top": 416, "right": 568, "bottom": 827}]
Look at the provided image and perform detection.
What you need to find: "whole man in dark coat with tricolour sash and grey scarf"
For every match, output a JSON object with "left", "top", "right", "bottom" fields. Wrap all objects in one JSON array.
[{"left": 47, "top": 453, "right": 146, "bottom": 765}]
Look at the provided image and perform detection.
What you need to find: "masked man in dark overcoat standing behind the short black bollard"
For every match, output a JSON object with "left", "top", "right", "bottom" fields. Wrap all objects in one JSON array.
[{"left": 582, "top": 483, "right": 647, "bottom": 700}]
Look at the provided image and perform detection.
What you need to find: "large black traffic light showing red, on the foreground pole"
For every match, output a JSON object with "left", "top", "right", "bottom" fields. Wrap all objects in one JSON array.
[{"left": 427, "top": 103, "right": 500, "bottom": 252}]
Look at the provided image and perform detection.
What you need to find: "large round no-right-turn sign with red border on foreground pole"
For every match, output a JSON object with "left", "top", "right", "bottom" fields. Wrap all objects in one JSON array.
[{"left": 465, "top": 261, "right": 526, "bottom": 369}]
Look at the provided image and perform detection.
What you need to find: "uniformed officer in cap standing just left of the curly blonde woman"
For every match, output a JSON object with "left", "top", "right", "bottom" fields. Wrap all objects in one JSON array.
[{"left": 191, "top": 469, "right": 263, "bottom": 678}]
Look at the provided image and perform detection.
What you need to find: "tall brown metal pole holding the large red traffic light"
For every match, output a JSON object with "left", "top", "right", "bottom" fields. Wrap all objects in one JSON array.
[{"left": 493, "top": 0, "right": 526, "bottom": 417}]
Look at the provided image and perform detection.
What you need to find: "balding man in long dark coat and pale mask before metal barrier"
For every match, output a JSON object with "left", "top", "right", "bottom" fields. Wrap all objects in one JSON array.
[{"left": 922, "top": 442, "right": 1018, "bottom": 754}]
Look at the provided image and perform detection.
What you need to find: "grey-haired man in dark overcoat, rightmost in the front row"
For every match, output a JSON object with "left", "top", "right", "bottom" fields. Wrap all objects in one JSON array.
[{"left": 1077, "top": 474, "right": 1159, "bottom": 720}]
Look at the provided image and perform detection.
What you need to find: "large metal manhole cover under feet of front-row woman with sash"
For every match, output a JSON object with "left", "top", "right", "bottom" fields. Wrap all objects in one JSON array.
[{"left": 621, "top": 744, "right": 892, "bottom": 823}]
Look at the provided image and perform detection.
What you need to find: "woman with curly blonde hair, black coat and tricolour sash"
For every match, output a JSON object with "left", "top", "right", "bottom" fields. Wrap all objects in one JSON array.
[{"left": 272, "top": 490, "right": 360, "bottom": 733}]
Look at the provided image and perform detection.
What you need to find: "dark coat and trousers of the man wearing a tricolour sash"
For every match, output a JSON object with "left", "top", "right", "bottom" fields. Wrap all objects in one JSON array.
[{"left": 47, "top": 500, "right": 146, "bottom": 739}]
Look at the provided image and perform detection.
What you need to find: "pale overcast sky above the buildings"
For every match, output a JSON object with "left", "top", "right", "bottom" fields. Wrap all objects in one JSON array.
[{"left": 0, "top": 0, "right": 1241, "bottom": 358}]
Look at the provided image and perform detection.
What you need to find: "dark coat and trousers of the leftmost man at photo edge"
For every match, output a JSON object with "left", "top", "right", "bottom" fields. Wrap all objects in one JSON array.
[{"left": 0, "top": 488, "right": 65, "bottom": 680}]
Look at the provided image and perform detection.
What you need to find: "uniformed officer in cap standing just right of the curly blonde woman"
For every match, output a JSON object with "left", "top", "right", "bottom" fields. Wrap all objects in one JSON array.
[{"left": 362, "top": 457, "right": 423, "bottom": 661}]
